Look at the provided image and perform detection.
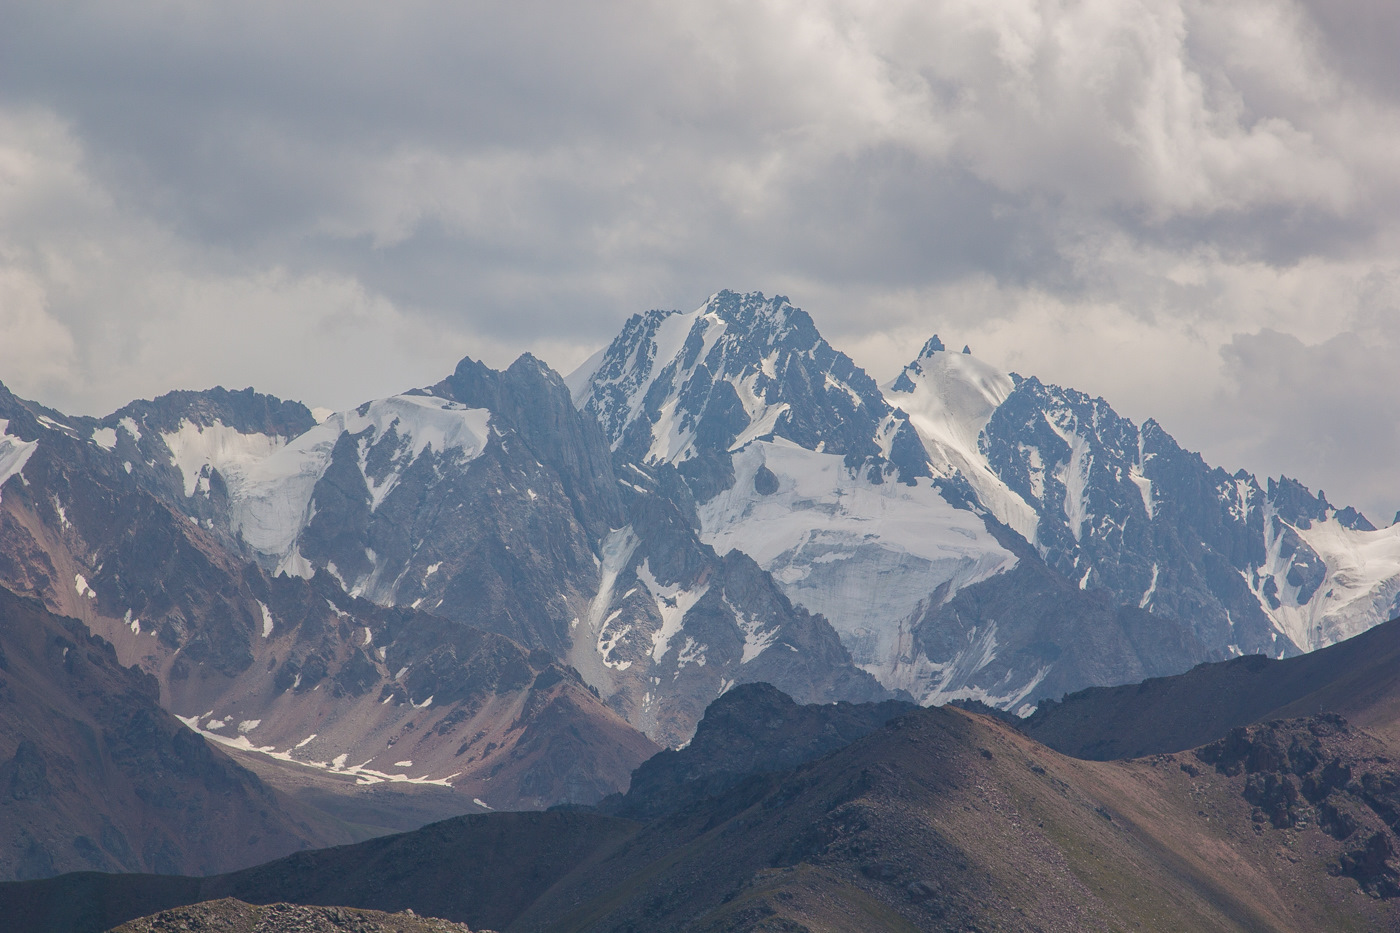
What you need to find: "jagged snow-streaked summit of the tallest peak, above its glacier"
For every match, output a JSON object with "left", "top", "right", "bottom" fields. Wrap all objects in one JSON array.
[{"left": 568, "top": 291, "right": 928, "bottom": 479}]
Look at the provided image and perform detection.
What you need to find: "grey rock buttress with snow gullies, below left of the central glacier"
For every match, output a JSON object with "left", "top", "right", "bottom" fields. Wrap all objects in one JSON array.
[{"left": 568, "top": 464, "right": 889, "bottom": 745}]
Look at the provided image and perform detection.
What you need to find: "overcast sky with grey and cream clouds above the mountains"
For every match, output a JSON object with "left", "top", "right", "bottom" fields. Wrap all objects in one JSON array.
[{"left": 0, "top": 0, "right": 1400, "bottom": 515}]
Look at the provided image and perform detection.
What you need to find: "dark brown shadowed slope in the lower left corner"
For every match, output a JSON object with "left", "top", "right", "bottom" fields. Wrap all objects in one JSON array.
[{"left": 0, "top": 588, "right": 349, "bottom": 880}]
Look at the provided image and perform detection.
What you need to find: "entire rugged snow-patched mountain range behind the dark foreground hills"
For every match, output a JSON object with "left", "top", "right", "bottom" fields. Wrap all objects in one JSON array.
[{"left": 0, "top": 285, "right": 1400, "bottom": 885}]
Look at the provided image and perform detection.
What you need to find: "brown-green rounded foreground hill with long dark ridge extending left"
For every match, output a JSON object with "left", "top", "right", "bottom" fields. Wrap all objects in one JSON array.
[{"left": 0, "top": 675, "right": 1400, "bottom": 933}]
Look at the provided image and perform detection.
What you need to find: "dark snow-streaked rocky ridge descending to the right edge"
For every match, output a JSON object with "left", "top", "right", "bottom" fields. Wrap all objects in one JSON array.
[{"left": 980, "top": 377, "right": 1400, "bottom": 657}]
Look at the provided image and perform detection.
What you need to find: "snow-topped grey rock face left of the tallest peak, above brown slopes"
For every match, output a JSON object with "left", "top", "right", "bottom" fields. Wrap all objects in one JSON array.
[{"left": 112, "top": 369, "right": 604, "bottom": 654}]
